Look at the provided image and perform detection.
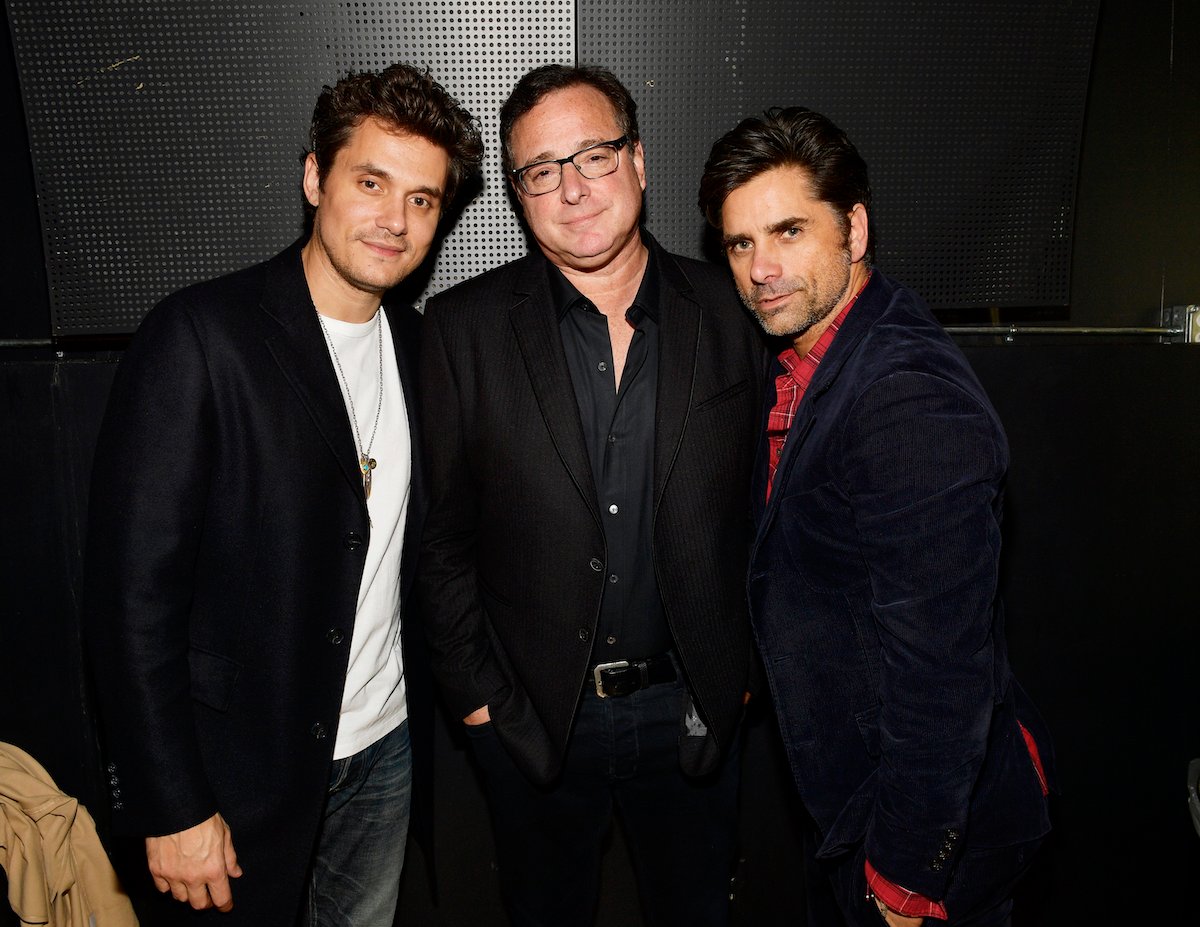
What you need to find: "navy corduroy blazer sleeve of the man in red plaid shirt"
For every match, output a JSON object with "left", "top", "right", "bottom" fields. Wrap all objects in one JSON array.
[{"left": 842, "top": 372, "right": 1007, "bottom": 898}]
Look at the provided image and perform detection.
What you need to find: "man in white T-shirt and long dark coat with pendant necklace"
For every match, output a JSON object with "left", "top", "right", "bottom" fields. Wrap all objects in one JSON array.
[{"left": 85, "top": 65, "right": 481, "bottom": 927}]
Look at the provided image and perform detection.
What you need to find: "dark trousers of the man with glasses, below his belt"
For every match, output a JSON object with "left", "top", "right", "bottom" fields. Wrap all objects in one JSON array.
[{"left": 467, "top": 681, "right": 738, "bottom": 927}]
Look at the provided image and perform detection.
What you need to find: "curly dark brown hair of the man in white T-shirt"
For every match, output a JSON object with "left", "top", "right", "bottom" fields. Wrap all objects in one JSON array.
[{"left": 308, "top": 64, "right": 484, "bottom": 207}]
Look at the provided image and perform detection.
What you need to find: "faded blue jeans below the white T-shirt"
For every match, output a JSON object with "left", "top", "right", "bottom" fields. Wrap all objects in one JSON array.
[{"left": 306, "top": 720, "right": 413, "bottom": 927}]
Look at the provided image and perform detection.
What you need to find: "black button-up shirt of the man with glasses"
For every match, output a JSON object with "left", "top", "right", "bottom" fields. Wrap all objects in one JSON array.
[{"left": 547, "top": 251, "right": 672, "bottom": 663}]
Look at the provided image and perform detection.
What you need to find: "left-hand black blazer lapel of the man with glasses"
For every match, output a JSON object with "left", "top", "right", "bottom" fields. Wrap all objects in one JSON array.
[{"left": 509, "top": 256, "right": 600, "bottom": 521}]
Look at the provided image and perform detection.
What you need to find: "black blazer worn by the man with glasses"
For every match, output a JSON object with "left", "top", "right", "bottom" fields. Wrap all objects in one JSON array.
[{"left": 418, "top": 240, "right": 762, "bottom": 783}]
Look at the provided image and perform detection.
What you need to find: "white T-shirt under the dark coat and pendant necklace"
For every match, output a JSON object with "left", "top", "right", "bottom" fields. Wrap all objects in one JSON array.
[{"left": 322, "top": 311, "right": 413, "bottom": 760}]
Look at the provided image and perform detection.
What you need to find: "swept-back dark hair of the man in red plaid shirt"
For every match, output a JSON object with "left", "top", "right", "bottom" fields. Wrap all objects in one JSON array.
[{"left": 698, "top": 106, "right": 875, "bottom": 264}]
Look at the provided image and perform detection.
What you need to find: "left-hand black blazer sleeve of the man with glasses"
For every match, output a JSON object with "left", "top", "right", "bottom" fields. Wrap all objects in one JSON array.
[{"left": 418, "top": 304, "right": 508, "bottom": 718}]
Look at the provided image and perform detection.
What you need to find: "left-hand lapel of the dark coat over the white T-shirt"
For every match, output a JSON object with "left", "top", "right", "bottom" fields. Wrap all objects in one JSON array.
[{"left": 260, "top": 243, "right": 367, "bottom": 510}]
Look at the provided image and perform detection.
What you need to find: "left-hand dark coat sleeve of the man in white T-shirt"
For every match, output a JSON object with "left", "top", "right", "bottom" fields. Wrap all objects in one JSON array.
[{"left": 84, "top": 297, "right": 217, "bottom": 835}]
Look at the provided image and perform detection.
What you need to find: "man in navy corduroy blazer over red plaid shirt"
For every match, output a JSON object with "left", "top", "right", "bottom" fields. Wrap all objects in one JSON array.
[{"left": 700, "top": 107, "right": 1052, "bottom": 927}]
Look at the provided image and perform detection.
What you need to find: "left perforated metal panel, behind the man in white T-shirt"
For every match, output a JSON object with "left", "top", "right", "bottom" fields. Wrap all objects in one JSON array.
[{"left": 8, "top": 0, "right": 575, "bottom": 335}]
